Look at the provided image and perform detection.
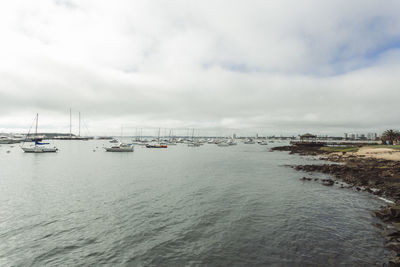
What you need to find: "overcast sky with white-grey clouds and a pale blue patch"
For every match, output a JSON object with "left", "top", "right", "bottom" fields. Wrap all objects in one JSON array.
[{"left": 0, "top": 0, "right": 400, "bottom": 135}]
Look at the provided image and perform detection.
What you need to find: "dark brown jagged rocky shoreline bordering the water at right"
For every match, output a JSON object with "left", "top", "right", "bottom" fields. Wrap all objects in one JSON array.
[{"left": 271, "top": 145, "right": 400, "bottom": 266}]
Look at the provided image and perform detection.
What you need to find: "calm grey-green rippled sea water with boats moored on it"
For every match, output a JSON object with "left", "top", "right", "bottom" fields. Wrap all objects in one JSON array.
[{"left": 0, "top": 140, "right": 388, "bottom": 266}]
